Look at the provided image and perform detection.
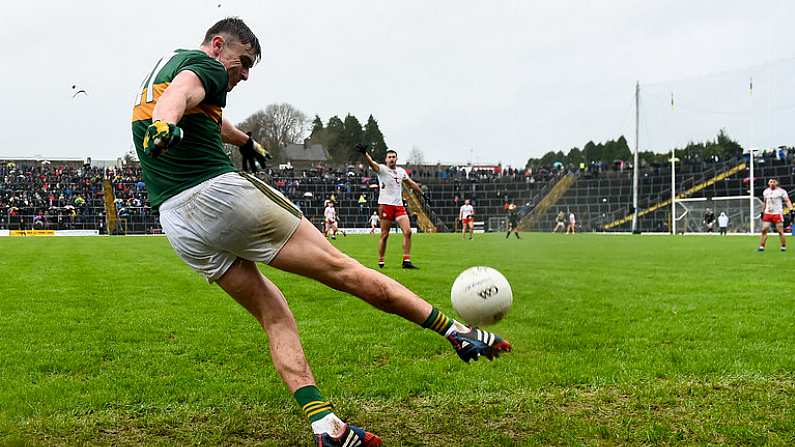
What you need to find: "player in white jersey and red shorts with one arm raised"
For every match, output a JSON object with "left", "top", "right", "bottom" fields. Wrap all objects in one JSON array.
[{"left": 356, "top": 144, "right": 422, "bottom": 269}]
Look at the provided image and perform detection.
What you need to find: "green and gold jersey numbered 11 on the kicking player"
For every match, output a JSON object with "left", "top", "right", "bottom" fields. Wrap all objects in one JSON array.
[{"left": 132, "top": 50, "right": 236, "bottom": 207}]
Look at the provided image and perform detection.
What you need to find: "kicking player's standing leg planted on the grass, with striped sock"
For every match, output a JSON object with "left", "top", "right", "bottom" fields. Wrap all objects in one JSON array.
[{"left": 218, "top": 260, "right": 381, "bottom": 446}]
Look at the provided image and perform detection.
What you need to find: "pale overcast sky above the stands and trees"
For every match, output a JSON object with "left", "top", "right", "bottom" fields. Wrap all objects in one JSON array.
[{"left": 0, "top": 0, "right": 795, "bottom": 165}]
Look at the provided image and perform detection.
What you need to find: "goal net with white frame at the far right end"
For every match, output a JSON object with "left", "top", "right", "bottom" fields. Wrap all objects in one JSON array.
[{"left": 674, "top": 196, "right": 764, "bottom": 233}]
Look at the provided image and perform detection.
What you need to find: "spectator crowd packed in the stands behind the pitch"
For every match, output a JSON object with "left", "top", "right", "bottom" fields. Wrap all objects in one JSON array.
[{"left": 0, "top": 147, "right": 795, "bottom": 233}]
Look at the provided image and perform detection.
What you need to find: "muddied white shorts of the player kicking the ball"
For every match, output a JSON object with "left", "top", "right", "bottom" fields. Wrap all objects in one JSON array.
[{"left": 160, "top": 172, "right": 301, "bottom": 282}]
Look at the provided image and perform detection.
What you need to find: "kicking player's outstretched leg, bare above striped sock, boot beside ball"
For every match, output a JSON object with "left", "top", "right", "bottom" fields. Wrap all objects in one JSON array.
[{"left": 271, "top": 219, "right": 511, "bottom": 361}]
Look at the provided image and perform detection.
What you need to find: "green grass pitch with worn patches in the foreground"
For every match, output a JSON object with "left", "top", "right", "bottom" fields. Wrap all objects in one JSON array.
[{"left": 0, "top": 234, "right": 795, "bottom": 446}]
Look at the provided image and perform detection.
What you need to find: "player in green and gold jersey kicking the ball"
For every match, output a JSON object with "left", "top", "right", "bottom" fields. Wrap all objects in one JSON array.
[{"left": 132, "top": 18, "right": 511, "bottom": 447}]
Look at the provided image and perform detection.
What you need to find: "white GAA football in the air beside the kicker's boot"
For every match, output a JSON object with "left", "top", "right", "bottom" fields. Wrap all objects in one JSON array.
[{"left": 450, "top": 267, "right": 513, "bottom": 326}]
